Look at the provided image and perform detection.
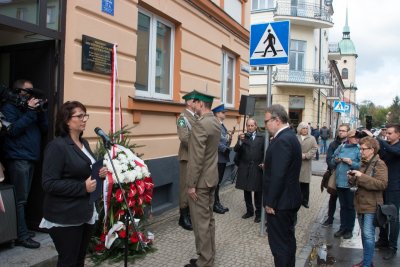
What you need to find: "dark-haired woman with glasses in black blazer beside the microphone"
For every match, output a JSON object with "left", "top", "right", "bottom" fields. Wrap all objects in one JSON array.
[{"left": 39, "top": 101, "right": 107, "bottom": 266}]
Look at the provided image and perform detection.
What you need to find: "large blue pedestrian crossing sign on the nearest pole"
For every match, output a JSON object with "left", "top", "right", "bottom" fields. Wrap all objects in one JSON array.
[{"left": 250, "top": 21, "right": 290, "bottom": 66}]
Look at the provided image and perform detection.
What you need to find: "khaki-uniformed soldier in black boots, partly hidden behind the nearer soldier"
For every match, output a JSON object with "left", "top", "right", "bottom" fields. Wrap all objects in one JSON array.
[{"left": 176, "top": 91, "right": 197, "bottom": 231}]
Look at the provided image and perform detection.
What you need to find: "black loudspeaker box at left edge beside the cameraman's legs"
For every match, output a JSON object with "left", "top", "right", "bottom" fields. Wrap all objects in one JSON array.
[{"left": 0, "top": 183, "right": 17, "bottom": 244}]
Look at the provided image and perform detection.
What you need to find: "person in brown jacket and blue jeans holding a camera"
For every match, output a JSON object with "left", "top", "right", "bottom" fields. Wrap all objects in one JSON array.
[{"left": 348, "top": 136, "right": 388, "bottom": 267}]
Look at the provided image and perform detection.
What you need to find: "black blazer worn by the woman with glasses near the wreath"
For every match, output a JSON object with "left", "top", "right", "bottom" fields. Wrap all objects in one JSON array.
[{"left": 42, "top": 136, "right": 93, "bottom": 224}]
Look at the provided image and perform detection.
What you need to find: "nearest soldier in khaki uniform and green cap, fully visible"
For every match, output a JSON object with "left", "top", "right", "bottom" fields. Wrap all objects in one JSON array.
[{"left": 185, "top": 92, "right": 221, "bottom": 267}]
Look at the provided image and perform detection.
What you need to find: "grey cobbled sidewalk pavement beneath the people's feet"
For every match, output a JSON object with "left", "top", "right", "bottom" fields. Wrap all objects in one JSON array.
[{"left": 0, "top": 155, "right": 400, "bottom": 267}]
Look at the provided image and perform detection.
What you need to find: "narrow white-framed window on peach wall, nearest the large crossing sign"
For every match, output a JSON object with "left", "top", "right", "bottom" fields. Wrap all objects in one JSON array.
[{"left": 221, "top": 51, "right": 236, "bottom": 107}]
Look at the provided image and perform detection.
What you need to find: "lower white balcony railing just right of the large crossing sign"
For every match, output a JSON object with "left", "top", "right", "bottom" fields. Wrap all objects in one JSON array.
[{"left": 273, "top": 69, "right": 332, "bottom": 85}]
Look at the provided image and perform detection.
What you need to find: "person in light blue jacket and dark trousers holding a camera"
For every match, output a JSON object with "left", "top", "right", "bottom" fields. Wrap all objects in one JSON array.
[{"left": 331, "top": 130, "right": 360, "bottom": 239}]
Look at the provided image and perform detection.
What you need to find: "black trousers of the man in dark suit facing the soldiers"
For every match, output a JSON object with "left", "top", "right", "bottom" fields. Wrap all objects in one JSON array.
[{"left": 267, "top": 210, "right": 297, "bottom": 267}]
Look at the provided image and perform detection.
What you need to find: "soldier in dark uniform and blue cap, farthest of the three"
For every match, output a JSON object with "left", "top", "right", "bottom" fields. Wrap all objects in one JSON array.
[{"left": 212, "top": 104, "right": 232, "bottom": 214}]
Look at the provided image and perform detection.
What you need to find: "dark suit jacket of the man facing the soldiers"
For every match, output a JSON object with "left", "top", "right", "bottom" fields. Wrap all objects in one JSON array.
[{"left": 263, "top": 128, "right": 302, "bottom": 210}]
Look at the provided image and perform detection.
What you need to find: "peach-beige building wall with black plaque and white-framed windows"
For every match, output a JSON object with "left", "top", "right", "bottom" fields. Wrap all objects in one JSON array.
[{"left": 64, "top": 0, "right": 250, "bottom": 159}]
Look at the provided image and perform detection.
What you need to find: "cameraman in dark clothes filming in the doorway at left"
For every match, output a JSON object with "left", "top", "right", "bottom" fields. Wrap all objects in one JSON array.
[{"left": 0, "top": 79, "right": 48, "bottom": 248}]
